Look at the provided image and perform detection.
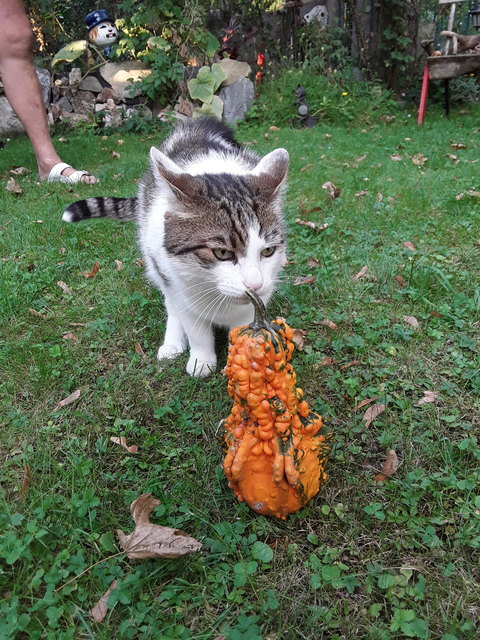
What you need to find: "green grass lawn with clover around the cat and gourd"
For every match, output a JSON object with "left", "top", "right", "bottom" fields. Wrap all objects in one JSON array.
[{"left": 0, "top": 108, "right": 480, "bottom": 640}]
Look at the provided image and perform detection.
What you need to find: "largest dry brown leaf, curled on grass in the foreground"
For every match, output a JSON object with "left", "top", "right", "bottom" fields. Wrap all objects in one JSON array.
[{"left": 117, "top": 493, "right": 202, "bottom": 560}]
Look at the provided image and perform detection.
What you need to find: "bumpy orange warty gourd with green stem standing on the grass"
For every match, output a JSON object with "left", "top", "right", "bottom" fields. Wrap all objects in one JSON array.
[{"left": 223, "top": 290, "right": 332, "bottom": 518}]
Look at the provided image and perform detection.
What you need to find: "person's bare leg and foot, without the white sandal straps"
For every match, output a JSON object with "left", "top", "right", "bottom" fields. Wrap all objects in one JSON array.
[{"left": 0, "top": 0, "right": 98, "bottom": 184}]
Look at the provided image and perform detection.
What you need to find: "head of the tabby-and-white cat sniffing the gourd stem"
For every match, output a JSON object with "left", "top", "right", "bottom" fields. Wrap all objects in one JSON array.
[{"left": 151, "top": 149, "right": 289, "bottom": 303}]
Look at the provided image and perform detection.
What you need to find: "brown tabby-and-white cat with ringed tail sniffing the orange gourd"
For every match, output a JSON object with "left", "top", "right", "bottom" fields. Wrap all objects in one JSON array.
[{"left": 62, "top": 118, "right": 289, "bottom": 377}]
